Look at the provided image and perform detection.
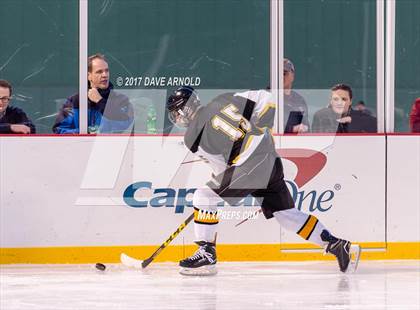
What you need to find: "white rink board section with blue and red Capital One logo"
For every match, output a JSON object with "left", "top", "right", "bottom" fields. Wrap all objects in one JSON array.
[{"left": 0, "top": 136, "right": 385, "bottom": 248}]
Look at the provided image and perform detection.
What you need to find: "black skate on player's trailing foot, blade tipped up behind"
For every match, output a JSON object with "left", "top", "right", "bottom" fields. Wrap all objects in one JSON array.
[{"left": 321, "top": 230, "right": 361, "bottom": 272}]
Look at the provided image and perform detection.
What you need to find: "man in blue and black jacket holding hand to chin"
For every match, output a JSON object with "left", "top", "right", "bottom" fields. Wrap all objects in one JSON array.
[{"left": 53, "top": 54, "right": 134, "bottom": 134}]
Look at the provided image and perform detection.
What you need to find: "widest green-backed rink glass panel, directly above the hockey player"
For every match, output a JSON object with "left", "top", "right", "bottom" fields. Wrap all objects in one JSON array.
[{"left": 89, "top": 0, "right": 270, "bottom": 133}]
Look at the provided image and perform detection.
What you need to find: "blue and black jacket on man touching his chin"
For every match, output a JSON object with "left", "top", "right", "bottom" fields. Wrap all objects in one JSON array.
[{"left": 53, "top": 84, "right": 134, "bottom": 134}]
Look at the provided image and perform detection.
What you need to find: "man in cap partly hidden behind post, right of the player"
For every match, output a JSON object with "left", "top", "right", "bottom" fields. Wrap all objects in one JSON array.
[{"left": 283, "top": 59, "right": 309, "bottom": 133}]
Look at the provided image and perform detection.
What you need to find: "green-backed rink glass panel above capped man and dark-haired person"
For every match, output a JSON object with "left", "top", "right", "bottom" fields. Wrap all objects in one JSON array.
[{"left": 284, "top": 0, "right": 377, "bottom": 124}]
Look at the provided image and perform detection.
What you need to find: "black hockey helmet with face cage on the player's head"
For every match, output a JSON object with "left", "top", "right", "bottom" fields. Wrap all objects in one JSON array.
[{"left": 166, "top": 86, "right": 200, "bottom": 127}]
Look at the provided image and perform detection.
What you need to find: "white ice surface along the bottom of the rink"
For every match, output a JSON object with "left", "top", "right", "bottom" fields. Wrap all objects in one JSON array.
[{"left": 0, "top": 261, "right": 420, "bottom": 310}]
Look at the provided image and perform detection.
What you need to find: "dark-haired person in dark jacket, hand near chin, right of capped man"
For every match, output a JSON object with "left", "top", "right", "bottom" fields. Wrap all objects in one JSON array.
[{"left": 312, "top": 84, "right": 377, "bottom": 133}]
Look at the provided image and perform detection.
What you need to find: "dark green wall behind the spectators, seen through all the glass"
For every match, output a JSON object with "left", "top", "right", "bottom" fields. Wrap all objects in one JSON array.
[{"left": 0, "top": 0, "right": 420, "bottom": 133}]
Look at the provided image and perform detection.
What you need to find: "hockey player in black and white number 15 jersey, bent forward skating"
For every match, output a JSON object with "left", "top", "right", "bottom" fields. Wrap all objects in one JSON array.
[{"left": 167, "top": 86, "right": 360, "bottom": 274}]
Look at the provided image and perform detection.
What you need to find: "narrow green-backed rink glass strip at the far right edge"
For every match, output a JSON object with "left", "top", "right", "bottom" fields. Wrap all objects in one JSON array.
[{"left": 394, "top": 0, "right": 420, "bottom": 132}]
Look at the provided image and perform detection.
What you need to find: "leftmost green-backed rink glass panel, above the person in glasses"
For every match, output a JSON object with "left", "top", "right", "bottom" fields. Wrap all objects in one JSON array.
[{"left": 0, "top": 0, "right": 79, "bottom": 133}]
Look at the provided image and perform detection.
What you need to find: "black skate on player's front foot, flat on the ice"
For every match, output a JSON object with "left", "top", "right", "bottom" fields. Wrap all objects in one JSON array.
[{"left": 179, "top": 241, "right": 217, "bottom": 276}]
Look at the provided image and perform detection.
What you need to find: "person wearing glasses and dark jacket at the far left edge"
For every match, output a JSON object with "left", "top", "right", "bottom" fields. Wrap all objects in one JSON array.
[{"left": 0, "top": 80, "right": 35, "bottom": 134}]
